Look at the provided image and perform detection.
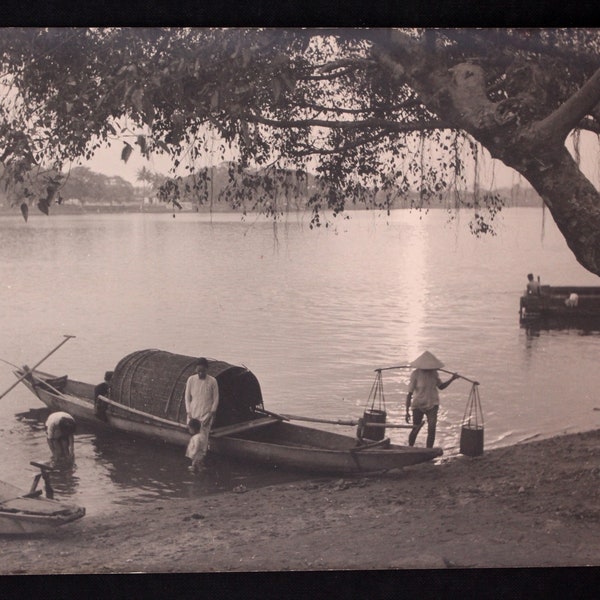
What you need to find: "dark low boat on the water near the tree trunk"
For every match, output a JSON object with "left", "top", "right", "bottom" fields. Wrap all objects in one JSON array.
[{"left": 519, "top": 285, "right": 600, "bottom": 323}]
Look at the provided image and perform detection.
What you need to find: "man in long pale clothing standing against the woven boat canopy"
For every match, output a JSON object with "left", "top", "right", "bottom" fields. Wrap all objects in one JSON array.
[{"left": 185, "top": 358, "right": 219, "bottom": 466}]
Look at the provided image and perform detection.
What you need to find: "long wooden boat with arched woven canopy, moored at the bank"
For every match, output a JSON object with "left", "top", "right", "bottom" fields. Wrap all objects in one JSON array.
[{"left": 15, "top": 350, "right": 442, "bottom": 473}]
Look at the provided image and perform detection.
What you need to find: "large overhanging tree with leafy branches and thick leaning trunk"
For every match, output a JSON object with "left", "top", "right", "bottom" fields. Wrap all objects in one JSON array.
[{"left": 0, "top": 28, "right": 600, "bottom": 273}]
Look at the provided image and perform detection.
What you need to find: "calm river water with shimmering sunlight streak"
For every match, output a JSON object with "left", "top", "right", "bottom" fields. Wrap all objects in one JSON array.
[{"left": 0, "top": 208, "right": 600, "bottom": 512}]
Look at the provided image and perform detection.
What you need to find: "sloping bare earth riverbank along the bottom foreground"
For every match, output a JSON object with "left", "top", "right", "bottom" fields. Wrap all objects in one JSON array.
[{"left": 0, "top": 430, "right": 600, "bottom": 574}]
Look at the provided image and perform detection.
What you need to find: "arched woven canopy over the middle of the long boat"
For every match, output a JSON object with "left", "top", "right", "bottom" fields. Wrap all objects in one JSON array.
[{"left": 108, "top": 350, "right": 263, "bottom": 427}]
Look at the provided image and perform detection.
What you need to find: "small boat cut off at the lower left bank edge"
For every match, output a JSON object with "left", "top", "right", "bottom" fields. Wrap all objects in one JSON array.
[{"left": 0, "top": 463, "right": 85, "bottom": 535}]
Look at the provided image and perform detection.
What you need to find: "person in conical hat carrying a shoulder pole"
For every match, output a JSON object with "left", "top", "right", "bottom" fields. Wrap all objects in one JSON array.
[{"left": 406, "top": 351, "right": 458, "bottom": 448}]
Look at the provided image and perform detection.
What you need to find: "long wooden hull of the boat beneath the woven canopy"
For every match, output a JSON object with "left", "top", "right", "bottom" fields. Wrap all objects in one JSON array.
[{"left": 17, "top": 373, "right": 442, "bottom": 473}]
